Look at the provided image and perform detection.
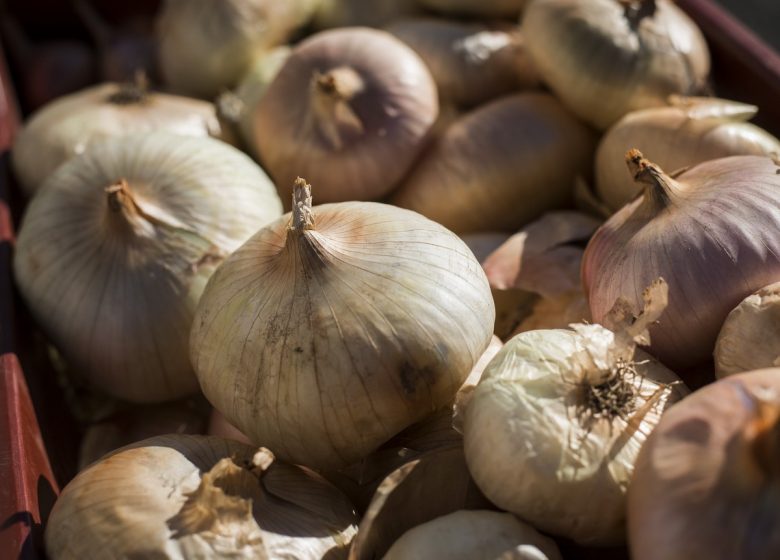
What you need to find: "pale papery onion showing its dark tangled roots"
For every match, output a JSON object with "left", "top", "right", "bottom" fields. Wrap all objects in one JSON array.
[{"left": 463, "top": 285, "right": 684, "bottom": 545}]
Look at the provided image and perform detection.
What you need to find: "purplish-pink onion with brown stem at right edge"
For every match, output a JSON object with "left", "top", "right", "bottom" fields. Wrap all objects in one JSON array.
[{"left": 582, "top": 150, "right": 780, "bottom": 369}]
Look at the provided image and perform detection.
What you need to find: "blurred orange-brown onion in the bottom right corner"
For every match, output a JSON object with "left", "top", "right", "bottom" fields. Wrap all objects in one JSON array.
[{"left": 628, "top": 368, "right": 780, "bottom": 560}]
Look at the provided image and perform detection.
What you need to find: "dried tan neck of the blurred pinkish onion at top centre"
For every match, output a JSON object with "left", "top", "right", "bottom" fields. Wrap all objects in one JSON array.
[{"left": 311, "top": 67, "right": 365, "bottom": 150}]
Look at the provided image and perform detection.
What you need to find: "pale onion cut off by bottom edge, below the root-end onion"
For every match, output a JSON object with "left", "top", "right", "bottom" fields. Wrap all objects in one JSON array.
[{"left": 382, "top": 510, "right": 563, "bottom": 560}]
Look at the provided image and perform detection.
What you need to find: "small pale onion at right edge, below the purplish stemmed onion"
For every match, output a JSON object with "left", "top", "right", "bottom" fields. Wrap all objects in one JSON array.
[{"left": 714, "top": 282, "right": 780, "bottom": 378}]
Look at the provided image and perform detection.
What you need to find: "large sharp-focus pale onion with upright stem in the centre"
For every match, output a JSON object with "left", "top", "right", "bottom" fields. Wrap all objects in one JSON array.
[{"left": 191, "top": 179, "right": 495, "bottom": 469}]
